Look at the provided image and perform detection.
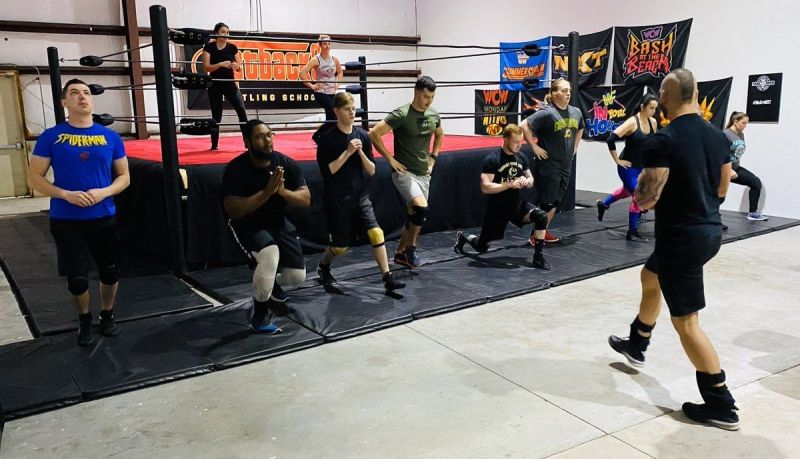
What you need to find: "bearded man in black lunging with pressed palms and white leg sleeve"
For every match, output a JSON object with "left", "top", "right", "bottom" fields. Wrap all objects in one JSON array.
[{"left": 227, "top": 120, "right": 311, "bottom": 333}]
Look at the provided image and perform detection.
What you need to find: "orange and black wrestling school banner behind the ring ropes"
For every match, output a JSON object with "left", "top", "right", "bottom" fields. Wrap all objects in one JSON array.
[{"left": 184, "top": 40, "right": 319, "bottom": 110}]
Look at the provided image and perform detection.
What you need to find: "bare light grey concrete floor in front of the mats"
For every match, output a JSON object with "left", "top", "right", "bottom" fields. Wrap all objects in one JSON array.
[{"left": 0, "top": 202, "right": 800, "bottom": 458}]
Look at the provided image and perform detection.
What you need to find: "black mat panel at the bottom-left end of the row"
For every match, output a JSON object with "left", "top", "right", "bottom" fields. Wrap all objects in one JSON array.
[{"left": 0, "top": 335, "right": 83, "bottom": 419}]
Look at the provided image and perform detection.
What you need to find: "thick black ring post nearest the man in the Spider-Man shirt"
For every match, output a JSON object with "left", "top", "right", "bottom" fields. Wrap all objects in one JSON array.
[{"left": 150, "top": 5, "right": 186, "bottom": 275}]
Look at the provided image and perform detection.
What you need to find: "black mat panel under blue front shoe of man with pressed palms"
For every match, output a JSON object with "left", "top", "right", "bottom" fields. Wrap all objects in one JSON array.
[{"left": 162, "top": 300, "right": 323, "bottom": 369}]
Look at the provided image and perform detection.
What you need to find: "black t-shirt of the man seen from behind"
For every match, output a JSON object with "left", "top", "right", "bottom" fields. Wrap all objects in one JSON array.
[{"left": 642, "top": 114, "right": 730, "bottom": 242}]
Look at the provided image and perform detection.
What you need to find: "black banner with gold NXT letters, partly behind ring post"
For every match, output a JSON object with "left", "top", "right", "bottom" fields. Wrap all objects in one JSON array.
[{"left": 552, "top": 28, "right": 613, "bottom": 87}]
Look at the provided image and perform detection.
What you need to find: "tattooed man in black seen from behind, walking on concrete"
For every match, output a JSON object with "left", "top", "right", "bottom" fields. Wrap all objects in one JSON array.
[{"left": 608, "top": 69, "right": 739, "bottom": 430}]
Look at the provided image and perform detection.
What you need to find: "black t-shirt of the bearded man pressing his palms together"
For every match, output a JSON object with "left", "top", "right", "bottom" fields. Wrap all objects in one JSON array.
[{"left": 222, "top": 152, "right": 306, "bottom": 232}]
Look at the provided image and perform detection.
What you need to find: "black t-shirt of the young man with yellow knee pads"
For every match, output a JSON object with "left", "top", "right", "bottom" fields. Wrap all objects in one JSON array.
[{"left": 312, "top": 124, "right": 375, "bottom": 202}]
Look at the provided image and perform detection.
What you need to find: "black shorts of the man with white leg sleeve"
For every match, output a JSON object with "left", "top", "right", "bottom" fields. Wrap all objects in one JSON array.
[{"left": 229, "top": 222, "right": 306, "bottom": 269}]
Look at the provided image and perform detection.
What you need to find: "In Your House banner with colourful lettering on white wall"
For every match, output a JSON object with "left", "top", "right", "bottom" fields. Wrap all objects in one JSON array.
[{"left": 576, "top": 85, "right": 646, "bottom": 141}]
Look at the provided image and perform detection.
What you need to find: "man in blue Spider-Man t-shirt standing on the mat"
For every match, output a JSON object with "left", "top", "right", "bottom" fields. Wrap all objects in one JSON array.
[{"left": 28, "top": 79, "right": 130, "bottom": 346}]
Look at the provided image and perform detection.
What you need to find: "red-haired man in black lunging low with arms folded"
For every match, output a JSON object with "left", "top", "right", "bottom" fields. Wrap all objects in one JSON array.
[{"left": 453, "top": 124, "right": 550, "bottom": 269}]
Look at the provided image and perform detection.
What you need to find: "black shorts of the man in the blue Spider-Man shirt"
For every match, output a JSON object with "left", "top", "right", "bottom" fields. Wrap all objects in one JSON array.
[{"left": 50, "top": 216, "right": 121, "bottom": 277}]
